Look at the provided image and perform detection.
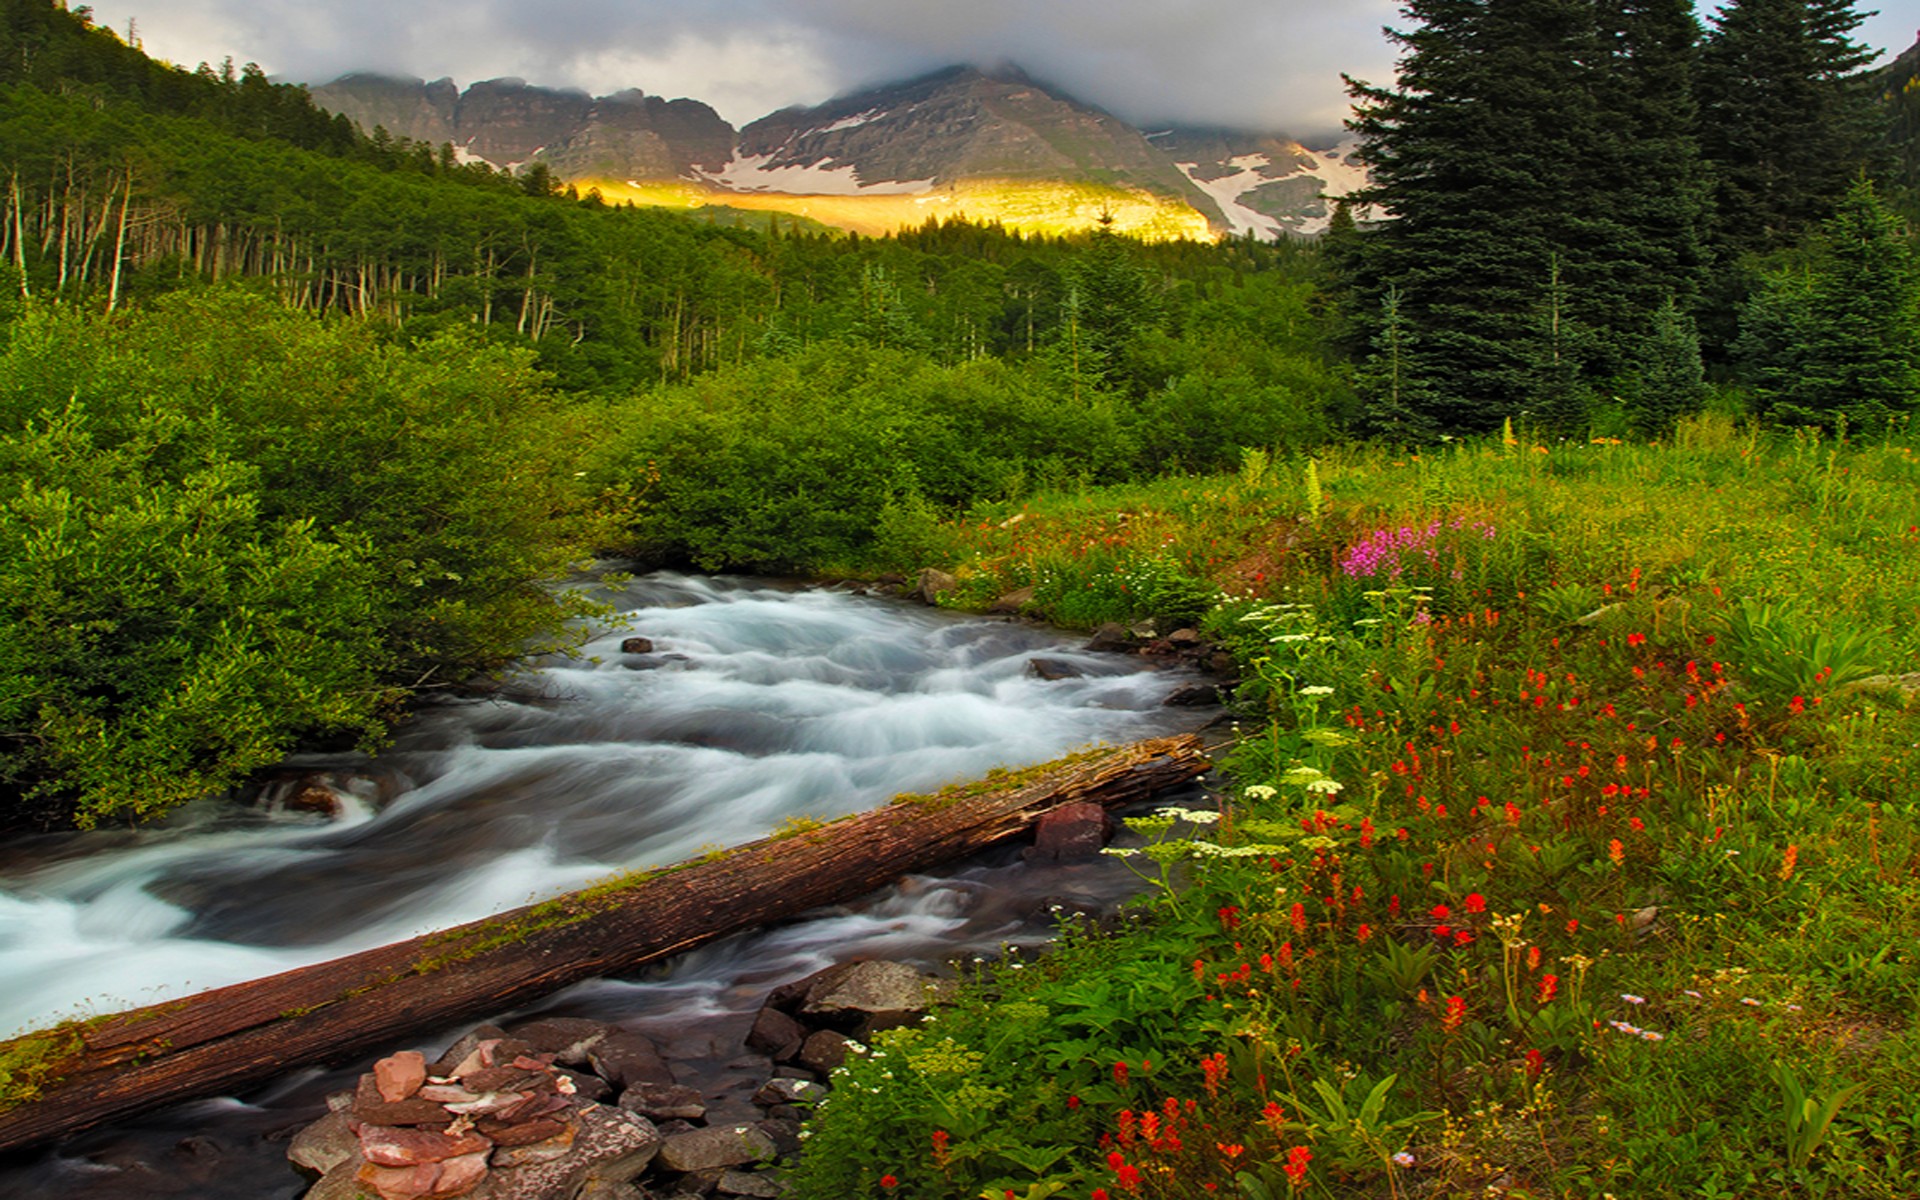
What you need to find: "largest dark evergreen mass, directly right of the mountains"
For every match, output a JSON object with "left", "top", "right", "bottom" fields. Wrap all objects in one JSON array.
[{"left": 1334, "top": 0, "right": 1705, "bottom": 432}]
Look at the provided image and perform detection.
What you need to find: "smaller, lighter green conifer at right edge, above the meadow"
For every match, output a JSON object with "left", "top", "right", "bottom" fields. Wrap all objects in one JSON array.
[{"left": 1736, "top": 179, "right": 1920, "bottom": 430}]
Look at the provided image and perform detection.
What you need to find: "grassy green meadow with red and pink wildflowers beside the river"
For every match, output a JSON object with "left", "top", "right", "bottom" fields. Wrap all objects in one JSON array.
[{"left": 797, "top": 417, "right": 1920, "bottom": 1200}]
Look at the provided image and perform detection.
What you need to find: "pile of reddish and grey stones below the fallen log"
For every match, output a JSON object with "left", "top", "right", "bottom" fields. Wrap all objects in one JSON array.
[{"left": 288, "top": 962, "right": 937, "bottom": 1200}]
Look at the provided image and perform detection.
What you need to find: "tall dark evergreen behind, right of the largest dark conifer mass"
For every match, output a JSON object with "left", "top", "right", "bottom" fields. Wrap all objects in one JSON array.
[{"left": 1699, "top": 0, "right": 1884, "bottom": 255}]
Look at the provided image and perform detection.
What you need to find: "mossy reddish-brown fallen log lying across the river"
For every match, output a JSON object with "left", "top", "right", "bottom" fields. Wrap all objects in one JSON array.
[{"left": 0, "top": 737, "right": 1208, "bottom": 1150}]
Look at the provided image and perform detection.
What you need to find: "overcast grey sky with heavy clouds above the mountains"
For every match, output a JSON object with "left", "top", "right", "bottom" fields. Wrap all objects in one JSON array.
[{"left": 67, "top": 0, "right": 1914, "bottom": 136}]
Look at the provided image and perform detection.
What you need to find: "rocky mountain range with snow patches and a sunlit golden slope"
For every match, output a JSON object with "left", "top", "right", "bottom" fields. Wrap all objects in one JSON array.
[{"left": 313, "top": 67, "right": 1361, "bottom": 238}]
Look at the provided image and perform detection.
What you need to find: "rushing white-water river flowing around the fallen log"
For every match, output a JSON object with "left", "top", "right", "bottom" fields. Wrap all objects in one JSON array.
[{"left": 0, "top": 576, "right": 1204, "bottom": 1200}]
